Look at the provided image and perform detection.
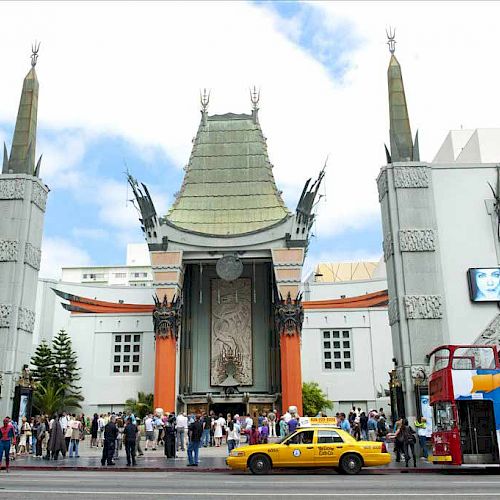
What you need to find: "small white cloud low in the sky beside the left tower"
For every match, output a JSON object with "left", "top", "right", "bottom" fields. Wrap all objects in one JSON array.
[{"left": 40, "top": 237, "right": 92, "bottom": 278}]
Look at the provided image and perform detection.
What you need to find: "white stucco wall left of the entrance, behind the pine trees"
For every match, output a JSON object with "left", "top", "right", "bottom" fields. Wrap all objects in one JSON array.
[{"left": 33, "top": 280, "right": 154, "bottom": 413}]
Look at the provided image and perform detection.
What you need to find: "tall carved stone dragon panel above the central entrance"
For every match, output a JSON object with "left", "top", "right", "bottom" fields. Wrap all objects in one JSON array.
[{"left": 210, "top": 278, "right": 253, "bottom": 387}]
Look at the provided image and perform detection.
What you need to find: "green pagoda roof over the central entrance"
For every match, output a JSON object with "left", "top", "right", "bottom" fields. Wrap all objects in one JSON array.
[{"left": 166, "top": 111, "right": 290, "bottom": 236}]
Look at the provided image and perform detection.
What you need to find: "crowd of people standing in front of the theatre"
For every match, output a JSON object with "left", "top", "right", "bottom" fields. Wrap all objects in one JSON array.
[{"left": 0, "top": 407, "right": 428, "bottom": 470}]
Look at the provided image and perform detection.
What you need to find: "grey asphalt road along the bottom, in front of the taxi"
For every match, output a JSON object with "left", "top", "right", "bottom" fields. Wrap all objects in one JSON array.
[{"left": 0, "top": 471, "right": 500, "bottom": 500}]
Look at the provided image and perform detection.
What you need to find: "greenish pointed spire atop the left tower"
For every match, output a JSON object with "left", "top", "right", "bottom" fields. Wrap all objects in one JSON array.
[{"left": 8, "top": 43, "right": 40, "bottom": 175}]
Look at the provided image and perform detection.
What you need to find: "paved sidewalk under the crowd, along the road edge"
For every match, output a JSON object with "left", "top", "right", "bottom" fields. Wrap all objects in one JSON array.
[{"left": 5, "top": 440, "right": 484, "bottom": 474}]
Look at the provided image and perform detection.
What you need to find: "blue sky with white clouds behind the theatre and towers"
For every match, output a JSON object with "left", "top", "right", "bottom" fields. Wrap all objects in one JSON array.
[{"left": 0, "top": 2, "right": 500, "bottom": 277}]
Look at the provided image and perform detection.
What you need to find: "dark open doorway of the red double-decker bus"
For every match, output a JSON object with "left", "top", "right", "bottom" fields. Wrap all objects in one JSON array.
[{"left": 457, "top": 400, "right": 498, "bottom": 464}]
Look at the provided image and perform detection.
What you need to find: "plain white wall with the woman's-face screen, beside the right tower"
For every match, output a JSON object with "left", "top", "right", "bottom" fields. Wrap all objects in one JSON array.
[{"left": 432, "top": 164, "right": 499, "bottom": 344}]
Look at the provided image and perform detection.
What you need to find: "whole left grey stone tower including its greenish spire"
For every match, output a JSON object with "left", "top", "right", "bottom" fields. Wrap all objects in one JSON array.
[{"left": 0, "top": 46, "right": 49, "bottom": 416}]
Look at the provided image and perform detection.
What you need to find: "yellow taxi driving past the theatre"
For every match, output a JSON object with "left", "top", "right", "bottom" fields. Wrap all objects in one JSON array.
[{"left": 226, "top": 426, "right": 391, "bottom": 474}]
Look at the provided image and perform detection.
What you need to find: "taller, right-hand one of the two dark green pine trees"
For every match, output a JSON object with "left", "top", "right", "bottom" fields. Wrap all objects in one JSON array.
[{"left": 52, "top": 330, "right": 81, "bottom": 396}]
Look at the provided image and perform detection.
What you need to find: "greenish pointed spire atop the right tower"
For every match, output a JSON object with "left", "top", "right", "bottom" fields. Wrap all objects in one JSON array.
[{"left": 387, "top": 30, "right": 419, "bottom": 162}]
